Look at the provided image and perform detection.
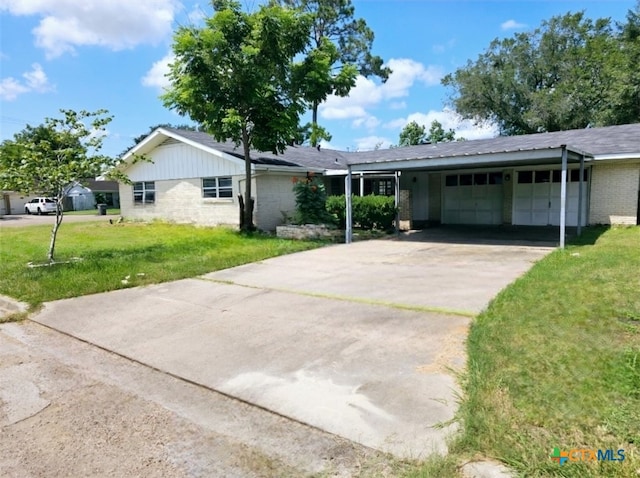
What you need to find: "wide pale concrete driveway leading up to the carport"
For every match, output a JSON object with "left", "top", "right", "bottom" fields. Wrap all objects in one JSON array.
[{"left": 33, "top": 240, "right": 551, "bottom": 458}]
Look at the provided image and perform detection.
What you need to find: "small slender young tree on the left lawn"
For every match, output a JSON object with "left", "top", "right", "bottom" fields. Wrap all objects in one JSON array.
[{"left": 0, "top": 110, "right": 127, "bottom": 263}]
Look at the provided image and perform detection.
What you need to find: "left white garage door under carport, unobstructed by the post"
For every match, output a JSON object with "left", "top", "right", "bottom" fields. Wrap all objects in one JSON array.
[{"left": 442, "top": 171, "right": 502, "bottom": 224}]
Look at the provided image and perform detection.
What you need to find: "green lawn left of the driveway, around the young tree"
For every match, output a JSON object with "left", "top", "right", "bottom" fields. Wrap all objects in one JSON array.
[{"left": 0, "top": 222, "right": 320, "bottom": 307}]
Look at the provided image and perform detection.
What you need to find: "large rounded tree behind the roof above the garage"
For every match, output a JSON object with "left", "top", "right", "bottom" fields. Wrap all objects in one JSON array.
[{"left": 443, "top": 12, "right": 622, "bottom": 134}]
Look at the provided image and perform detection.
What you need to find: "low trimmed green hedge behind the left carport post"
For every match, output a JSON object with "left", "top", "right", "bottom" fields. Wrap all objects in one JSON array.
[{"left": 327, "top": 194, "right": 396, "bottom": 231}]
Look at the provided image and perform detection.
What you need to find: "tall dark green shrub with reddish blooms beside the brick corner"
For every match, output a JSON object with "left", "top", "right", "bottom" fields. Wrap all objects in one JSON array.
[{"left": 293, "top": 173, "right": 335, "bottom": 225}]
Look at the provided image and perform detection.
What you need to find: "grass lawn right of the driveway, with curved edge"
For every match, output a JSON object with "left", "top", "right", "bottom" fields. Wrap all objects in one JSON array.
[{"left": 411, "top": 227, "right": 640, "bottom": 477}]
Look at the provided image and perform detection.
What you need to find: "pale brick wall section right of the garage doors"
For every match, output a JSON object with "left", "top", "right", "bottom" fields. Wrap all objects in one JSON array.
[{"left": 589, "top": 162, "right": 640, "bottom": 224}]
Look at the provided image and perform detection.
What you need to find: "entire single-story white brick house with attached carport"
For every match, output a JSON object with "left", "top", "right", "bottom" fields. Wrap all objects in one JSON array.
[{"left": 120, "top": 124, "right": 640, "bottom": 235}]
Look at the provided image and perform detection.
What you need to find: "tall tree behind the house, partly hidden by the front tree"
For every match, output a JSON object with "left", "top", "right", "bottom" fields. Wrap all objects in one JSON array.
[{"left": 272, "top": 0, "right": 391, "bottom": 146}]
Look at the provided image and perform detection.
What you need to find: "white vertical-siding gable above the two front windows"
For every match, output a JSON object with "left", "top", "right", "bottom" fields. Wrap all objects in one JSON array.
[{"left": 127, "top": 142, "right": 244, "bottom": 181}]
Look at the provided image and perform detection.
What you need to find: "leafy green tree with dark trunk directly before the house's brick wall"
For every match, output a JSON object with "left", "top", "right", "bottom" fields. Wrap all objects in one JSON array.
[{"left": 162, "top": 0, "right": 311, "bottom": 230}]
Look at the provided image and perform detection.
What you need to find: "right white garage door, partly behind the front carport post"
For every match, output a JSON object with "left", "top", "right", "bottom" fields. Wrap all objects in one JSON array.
[{"left": 513, "top": 169, "right": 589, "bottom": 226}]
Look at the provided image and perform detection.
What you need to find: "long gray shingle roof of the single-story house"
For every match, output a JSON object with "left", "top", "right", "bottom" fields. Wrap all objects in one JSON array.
[{"left": 166, "top": 123, "right": 640, "bottom": 169}]
